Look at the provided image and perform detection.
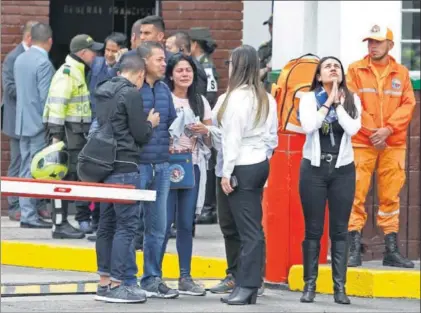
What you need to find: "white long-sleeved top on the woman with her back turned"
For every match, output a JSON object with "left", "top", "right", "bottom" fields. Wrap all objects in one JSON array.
[{"left": 212, "top": 86, "right": 278, "bottom": 178}]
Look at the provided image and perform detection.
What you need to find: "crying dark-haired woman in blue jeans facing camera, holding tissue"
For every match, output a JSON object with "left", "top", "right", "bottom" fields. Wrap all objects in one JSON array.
[{"left": 164, "top": 53, "right": 212, "bottom": 296}]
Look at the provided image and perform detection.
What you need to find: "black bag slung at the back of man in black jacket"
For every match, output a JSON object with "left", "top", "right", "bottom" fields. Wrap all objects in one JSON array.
[{"left": 76, "top": 105, "right": 117, "bottom": 183}]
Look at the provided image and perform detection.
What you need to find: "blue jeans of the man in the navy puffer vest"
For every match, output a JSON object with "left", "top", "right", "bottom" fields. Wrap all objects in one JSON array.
[{"left": 125, "top": 162, "right": 170, "bottom": 287}]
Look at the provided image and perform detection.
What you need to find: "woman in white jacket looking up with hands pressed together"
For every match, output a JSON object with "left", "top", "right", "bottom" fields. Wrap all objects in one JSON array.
[{"left": 299, "top": 56, "right": 361, "bottom": 304}]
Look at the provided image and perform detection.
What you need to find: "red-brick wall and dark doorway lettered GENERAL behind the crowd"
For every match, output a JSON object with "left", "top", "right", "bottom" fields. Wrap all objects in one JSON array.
[{"left": 1, "top": 0, "right": 243, "bottom": 208}]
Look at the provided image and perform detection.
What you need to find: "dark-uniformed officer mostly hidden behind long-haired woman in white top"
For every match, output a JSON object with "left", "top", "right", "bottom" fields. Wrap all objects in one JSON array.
[{"left": 189, "top": 27, "right": 219, "bottom": 224}]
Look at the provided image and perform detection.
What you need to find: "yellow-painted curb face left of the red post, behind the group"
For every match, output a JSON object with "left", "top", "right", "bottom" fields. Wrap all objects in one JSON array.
[{"left": 1, "top": 240, "right": 227, "bottom": 279}]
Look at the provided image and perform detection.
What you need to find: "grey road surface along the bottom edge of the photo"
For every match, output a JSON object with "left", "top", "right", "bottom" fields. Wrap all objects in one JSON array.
[{"left": 1, "top": 290, "right": 420, "bottom": 313}]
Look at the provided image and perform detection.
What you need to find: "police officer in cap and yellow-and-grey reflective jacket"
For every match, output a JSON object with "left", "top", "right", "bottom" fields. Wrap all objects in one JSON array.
[{"left": 43, "top": 34, "right": 104, "bottom": 239}]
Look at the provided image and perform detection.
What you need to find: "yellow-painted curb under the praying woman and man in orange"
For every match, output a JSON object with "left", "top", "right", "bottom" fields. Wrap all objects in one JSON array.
[{"left": 288, "top": 265, "right": 420, "bottom": 299}]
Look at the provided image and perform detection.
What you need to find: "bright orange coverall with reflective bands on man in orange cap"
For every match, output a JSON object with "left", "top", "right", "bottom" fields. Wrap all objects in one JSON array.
[{"left": 347, "top": 56, "right": 416, "bottom": 235}]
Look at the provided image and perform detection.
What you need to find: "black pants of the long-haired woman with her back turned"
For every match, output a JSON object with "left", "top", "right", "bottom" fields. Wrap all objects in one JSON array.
[{"left": 216, "top": 160, "right": 269, "bottom": 288}]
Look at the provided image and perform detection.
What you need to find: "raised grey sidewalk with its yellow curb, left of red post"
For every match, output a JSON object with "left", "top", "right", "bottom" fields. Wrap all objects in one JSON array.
[{"left": 1, "top": 217, "right": 226, "bottom": 279}]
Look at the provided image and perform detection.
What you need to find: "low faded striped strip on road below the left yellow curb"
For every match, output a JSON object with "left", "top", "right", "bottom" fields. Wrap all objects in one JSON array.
[{"left": 1, "top": 279, "right": 219, "bottom": 297}]
